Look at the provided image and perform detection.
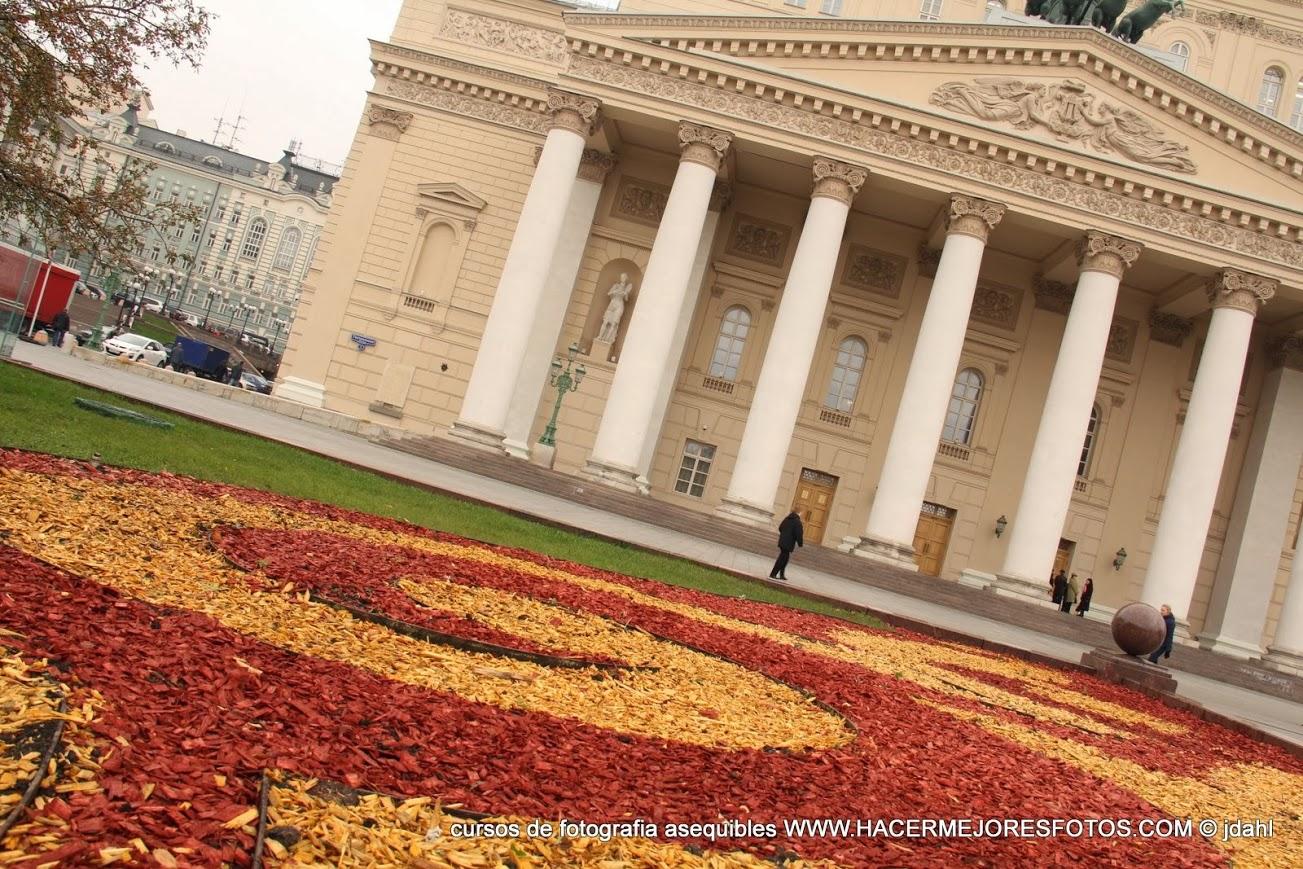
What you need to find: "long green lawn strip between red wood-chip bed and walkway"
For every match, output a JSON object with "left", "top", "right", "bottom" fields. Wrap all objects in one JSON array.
[{"left": 0, "top": 363, "right": 883, "bottom": 627}]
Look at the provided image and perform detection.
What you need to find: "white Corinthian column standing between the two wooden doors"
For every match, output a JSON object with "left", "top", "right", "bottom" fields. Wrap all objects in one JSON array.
[{"left": 842, "top": 194, "right": 1005, "bottom": 569}]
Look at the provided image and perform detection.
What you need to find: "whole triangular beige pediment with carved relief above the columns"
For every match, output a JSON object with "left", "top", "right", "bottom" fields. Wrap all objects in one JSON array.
[{"left": 567, "top": 14, "right": 1303, "bottom": 210}]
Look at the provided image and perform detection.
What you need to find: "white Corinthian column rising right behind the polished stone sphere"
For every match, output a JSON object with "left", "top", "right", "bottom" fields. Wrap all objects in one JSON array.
[{"left": 1140, "top": 268, "right": 1276, "bottom": 621}]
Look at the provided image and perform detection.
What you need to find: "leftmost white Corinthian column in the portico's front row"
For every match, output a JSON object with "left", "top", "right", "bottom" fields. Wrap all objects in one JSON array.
[{"left": 448, "top": 90, "right": 598, "bottom": 449}]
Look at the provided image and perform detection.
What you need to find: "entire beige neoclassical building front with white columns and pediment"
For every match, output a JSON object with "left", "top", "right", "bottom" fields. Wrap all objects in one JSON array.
[{"left": 278, "top": 0, "right": 1303, "bottom": 667}]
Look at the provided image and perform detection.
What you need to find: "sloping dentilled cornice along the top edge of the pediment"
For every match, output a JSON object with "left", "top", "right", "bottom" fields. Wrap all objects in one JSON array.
[{"left": 566, "top": 13, "right": 1303, "bottom": 169}]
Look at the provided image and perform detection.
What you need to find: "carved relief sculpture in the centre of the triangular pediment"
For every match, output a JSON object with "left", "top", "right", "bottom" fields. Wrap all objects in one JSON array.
[{"left": 930, "top": 77, "right": 1197, "bottom": 173}]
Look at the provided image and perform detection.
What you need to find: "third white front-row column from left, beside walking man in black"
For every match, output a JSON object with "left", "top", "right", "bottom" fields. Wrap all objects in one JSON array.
[{"left": 719, "top": 158, "right": 869, "bottom": 525}]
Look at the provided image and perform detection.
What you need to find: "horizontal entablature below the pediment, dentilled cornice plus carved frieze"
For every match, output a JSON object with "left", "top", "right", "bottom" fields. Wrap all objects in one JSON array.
[{"left": 567, "top": 48, "right": 1303, "bottom": 268}]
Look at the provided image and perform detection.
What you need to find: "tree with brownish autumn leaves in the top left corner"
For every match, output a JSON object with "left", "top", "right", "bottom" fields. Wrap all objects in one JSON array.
[{"left": 0, "top": 0, "right": 210, "bottom": 266}]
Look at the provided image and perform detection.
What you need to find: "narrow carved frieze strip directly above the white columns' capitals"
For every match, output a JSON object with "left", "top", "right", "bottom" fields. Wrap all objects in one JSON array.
[{"left": 571, "top": 56, "right": 1303, "bottom": 268}]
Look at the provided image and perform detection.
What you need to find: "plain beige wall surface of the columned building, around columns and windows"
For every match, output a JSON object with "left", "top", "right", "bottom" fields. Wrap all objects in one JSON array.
[{"left": 277, "top": 0, "right": 1303, "bottom": 642}]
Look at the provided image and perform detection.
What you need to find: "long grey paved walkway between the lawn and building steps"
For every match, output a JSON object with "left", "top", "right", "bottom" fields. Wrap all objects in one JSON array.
[{"left": 0, "top": 343, "right": 1303, "bottom": 745}]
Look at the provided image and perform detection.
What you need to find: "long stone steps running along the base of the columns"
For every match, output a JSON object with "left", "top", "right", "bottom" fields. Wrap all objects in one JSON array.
[{"left": 379, "top": 436, "right": 1303, "bottom": 702}]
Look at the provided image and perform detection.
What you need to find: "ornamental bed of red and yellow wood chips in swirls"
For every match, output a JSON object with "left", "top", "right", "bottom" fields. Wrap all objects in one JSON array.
[{"left": 0, "top": 451, "right": 1303, "bottom": 866}]
